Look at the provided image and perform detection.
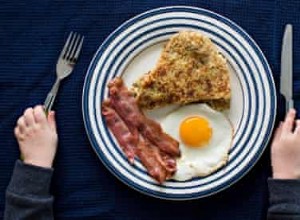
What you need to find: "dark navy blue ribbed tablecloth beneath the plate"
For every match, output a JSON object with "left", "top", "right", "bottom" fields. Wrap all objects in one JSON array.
[{"left": 0, "top": 0, "right": 300, "bottom": 220}]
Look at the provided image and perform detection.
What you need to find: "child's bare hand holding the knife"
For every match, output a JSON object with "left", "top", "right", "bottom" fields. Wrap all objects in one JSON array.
[{"left": 271, "top": 109, "right": 300, "bottom": 179}]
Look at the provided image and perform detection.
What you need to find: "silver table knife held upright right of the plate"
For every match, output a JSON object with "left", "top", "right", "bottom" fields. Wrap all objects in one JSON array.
[{"left": 280, "top": 24, "right": 294, "bottom": 112}]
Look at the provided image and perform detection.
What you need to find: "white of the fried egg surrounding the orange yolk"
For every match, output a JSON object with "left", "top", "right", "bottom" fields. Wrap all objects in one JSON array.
[{"left": 160, "top": 104, "right": 233, "bottom": 181}]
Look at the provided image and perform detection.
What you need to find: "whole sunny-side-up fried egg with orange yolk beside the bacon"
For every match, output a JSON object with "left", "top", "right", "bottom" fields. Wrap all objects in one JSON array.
[{"left": 161, "top": 104, "right": 233, "bottom": 181}]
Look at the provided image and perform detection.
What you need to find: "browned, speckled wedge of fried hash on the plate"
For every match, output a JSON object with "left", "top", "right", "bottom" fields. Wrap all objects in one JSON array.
[{"left": 132, "top": 31, "right": 230, "bottom": 110}]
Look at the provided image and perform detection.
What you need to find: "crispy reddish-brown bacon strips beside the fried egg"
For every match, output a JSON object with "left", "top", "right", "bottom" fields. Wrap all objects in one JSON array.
[{"left": 102, "top": 78, "right": 180, "bottom": 183}]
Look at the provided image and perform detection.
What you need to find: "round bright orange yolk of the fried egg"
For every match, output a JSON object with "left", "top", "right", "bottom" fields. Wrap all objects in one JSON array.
[{"left": 179, "top": 116, "right": 212, "bottom": 147}]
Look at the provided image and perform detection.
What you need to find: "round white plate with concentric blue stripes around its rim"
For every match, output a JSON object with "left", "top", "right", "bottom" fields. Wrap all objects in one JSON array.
[{"left": 83, "top": 6, "right": 276, "bottom": 200}]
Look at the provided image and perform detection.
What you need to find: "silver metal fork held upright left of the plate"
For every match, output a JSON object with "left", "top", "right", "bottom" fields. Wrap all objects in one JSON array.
[{"left": 44, "top": 32, "right": 84, "bottom": 113}]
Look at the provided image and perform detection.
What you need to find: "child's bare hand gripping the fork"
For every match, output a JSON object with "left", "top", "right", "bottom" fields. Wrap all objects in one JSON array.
[{"left": 15, "top": 106, "right": 57, "bottom": 167}]
